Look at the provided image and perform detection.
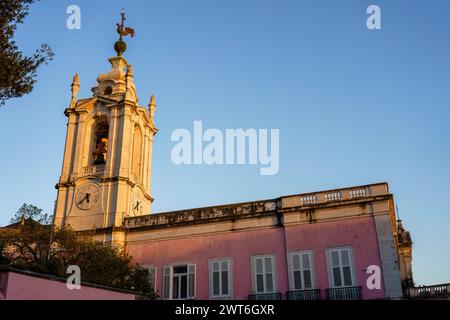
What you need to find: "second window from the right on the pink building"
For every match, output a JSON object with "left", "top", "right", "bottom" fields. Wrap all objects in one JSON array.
[{"left": 289, "top": 251, "right": 314, "bottom": 290}]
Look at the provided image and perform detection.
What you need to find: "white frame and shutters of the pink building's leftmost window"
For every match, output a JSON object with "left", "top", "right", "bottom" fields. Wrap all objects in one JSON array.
[{"left": 162, "top": 263, "right": 197, "bottom": 300}]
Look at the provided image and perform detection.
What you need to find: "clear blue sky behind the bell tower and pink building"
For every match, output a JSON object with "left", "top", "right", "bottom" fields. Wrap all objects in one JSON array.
[{"left": 0, "top": 0, "right": 450, "bottom": 284}]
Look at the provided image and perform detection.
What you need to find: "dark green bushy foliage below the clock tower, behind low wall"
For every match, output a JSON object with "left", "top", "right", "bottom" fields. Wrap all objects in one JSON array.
[{"left": 0, "top": 205, "right": 156, "bottom": 299}]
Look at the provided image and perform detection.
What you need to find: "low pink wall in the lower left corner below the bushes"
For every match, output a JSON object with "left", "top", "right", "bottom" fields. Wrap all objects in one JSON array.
[{"left": 0, "top": 271, "right": 135, "bottom": 300}]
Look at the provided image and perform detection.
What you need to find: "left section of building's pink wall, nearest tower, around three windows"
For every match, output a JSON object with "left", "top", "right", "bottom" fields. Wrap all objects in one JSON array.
[{"left": 127, "top": 228, "right": 287, "bottom": 299}]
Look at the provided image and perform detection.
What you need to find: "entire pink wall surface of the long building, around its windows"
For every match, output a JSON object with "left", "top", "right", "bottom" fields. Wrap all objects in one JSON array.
[{"left": 127, "top": 218, "right": 384, "bottom": 299}]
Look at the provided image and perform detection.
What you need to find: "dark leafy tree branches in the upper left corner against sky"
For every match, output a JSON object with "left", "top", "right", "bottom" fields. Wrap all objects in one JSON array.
[{"left": 0, "top": 0, "right": 53, "bottom": 106}]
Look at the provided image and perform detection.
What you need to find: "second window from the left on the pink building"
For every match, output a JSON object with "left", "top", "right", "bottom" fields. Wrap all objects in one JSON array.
[{"left": 209, "top": 259, "right": 233, "bottom": 299}]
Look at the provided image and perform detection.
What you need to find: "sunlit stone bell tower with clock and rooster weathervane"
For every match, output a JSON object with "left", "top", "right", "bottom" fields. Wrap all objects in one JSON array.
[{"left": 55, "top": 13, "right": 157, "bottom": 244}]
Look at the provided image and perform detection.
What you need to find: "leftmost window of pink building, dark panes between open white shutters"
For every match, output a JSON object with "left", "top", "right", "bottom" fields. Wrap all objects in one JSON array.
[{"left": 163, "top": 264, "right": 195, "bottom": 300}]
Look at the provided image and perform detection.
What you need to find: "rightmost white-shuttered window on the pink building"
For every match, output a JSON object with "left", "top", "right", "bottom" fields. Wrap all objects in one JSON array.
[{"left": 327, "top": 247, "right": 356, "bottom": 288}]
